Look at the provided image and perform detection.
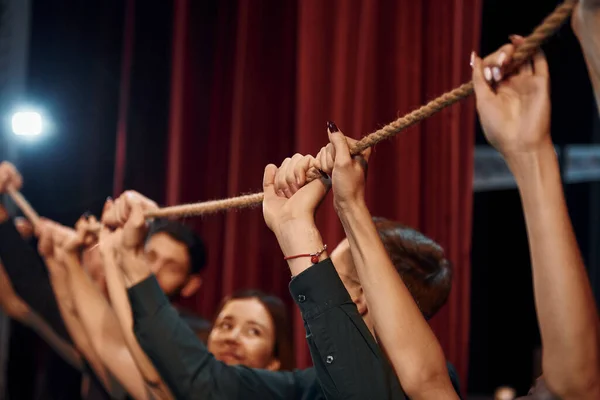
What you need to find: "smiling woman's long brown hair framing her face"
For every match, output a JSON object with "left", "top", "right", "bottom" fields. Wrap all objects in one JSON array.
[{"left": 214, "top": 289, "right": 295, "bottom": 371}]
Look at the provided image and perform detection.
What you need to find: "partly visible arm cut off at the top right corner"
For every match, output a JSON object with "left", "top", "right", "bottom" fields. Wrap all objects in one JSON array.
[{"left": 571, "top": 0, "right": 600, "bottom": 112}]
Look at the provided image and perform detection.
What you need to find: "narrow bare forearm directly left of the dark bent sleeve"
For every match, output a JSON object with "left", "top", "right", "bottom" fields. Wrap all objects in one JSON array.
[{"left": 103, "top": 253, "right": 172, "bottom": 398}]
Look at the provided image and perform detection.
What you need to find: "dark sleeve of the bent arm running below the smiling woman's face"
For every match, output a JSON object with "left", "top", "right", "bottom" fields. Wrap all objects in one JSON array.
[{"left": 128, "top": 275, "right": 320, "bottom": 400}]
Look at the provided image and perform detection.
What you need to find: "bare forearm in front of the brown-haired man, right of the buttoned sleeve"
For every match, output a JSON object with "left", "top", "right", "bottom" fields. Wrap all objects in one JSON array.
[{"left": 338, "top": 203, "right": 457, "bottom": 399}]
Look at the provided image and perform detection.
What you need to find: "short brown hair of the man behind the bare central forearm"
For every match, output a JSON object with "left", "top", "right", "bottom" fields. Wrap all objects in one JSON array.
[{"left": 373, "top": 217, "right": 452, "bottom": 319}]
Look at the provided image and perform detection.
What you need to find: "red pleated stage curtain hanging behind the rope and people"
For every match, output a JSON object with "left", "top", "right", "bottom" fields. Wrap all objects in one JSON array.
[{"left": 166, "top": 0, "right": 481, "bottom": 392}]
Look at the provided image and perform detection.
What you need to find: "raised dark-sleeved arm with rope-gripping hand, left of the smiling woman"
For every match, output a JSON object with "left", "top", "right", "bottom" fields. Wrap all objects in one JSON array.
[{"left": 102, "top": 192, "right": 308, "bottom": 400}]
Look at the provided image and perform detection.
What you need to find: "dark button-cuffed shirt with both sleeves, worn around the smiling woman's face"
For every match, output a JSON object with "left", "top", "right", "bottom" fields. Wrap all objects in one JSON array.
[{"left": 129, "top": 260, "right": 460, "bottom": 400}]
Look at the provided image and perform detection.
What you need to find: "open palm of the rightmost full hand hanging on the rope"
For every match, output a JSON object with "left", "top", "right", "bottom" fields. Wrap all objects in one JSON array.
[{"left": 477, "top": 75, "right": 550, "bottom": 154}]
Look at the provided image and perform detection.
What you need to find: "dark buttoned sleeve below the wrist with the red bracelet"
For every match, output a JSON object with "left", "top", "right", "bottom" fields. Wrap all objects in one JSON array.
[{"left": 290, "top": 259, "right": 405, "bottom": 400}]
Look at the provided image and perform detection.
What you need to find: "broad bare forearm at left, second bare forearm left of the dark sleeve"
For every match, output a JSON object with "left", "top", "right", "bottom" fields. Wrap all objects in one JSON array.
[{"left": 65, "top": 257, "right": 150, "bottom": 399}]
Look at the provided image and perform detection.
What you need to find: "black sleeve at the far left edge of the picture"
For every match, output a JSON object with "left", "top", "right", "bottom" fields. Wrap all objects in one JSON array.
[{"left": 0, "top": 221, "right": 72, "bottom": 343}]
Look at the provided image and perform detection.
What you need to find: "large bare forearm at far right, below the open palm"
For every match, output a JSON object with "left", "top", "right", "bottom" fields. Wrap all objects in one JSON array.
[{"left": 509, "top": 145, "right": 600, "bottom": 398}]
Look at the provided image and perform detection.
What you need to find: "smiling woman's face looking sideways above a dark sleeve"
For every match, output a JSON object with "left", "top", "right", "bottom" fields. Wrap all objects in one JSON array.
[{"left": 208, "top": 298, "right": 280, "bottom": 370}]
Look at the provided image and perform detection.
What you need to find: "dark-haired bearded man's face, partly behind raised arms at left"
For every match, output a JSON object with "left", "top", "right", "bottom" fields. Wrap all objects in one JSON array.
[{"left": 145, "top": 233, "right": 191, "bottom": 296}]
